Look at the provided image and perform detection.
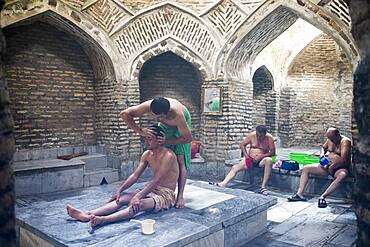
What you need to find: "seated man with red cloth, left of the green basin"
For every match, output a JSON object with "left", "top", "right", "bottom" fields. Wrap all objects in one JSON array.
[{"left": 211, "top": 125, "right": 276, "bottom": 195}]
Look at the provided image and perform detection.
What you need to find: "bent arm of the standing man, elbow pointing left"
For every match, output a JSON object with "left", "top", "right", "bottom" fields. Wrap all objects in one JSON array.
[{"left": 119, "top": 100, "right": 152, "bottom": 136}]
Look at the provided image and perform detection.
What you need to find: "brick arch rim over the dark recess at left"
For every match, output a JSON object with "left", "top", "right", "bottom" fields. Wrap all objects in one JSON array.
[{"left": 1, "top": 1, "right": 126, "bottom": 80}]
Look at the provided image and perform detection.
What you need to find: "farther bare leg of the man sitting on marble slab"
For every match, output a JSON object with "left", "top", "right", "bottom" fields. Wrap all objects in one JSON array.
[{"left": 67, "top": 193, "right": 133, "bottom": 222}]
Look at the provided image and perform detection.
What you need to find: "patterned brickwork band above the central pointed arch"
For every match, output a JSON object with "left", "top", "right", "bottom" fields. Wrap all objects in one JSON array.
[{"left": 110, "top": 2, "right": 220, "bottom": 71}]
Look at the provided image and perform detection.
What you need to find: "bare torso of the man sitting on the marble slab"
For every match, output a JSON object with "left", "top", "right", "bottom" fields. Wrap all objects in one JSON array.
[{"left": 145, "top": 148, "right": 179, "bottom": 190}]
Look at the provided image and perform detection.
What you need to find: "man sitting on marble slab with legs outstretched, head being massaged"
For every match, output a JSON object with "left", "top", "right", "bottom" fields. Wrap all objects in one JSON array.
[{"left": 67, "top": 125, "right": 179, "bottom": 227}]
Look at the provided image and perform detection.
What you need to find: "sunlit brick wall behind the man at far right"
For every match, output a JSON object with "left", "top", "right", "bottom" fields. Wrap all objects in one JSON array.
[{"left": 280, "top": 34, "right": 353, "bottom": 145}]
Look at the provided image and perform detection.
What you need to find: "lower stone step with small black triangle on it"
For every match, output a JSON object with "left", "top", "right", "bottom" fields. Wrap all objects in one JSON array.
[{"left": 83, "top": 167, "right": 119, "bottom": 187}]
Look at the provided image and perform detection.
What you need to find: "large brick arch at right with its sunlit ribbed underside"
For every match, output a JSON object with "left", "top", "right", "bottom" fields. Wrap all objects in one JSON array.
[{"left": 220, "top": 0, "right": 358, "bottom": 81}]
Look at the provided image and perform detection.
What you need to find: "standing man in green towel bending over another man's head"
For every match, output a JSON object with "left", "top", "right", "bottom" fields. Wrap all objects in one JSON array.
[{"left": 120, "top": 97, "right": 192, "bottom": 208}]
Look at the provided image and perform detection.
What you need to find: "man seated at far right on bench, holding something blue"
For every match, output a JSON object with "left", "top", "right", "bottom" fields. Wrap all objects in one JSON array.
[{"left": 288, "top": 128, "right": 351, "bottom": 208}]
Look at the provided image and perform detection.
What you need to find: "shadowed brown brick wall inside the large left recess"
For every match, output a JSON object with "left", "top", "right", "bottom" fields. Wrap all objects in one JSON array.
[{"left": 5, "top": 22, "right": 96, "bottom": 149}]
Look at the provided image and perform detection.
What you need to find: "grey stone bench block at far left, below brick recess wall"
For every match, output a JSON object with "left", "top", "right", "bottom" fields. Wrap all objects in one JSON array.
[{"left": 14, "top": 159, "right": 85, "bottom": 196}]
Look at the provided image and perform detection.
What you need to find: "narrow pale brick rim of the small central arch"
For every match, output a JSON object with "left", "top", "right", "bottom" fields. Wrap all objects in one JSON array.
[{"left": 129, "top": 38, "right": 212, "bottom": 80}]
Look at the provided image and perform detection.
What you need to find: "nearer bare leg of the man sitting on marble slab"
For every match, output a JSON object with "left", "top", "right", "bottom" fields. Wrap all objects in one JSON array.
[{"left": 90, "top": 198, "right": 155, "bottom": 227}]
